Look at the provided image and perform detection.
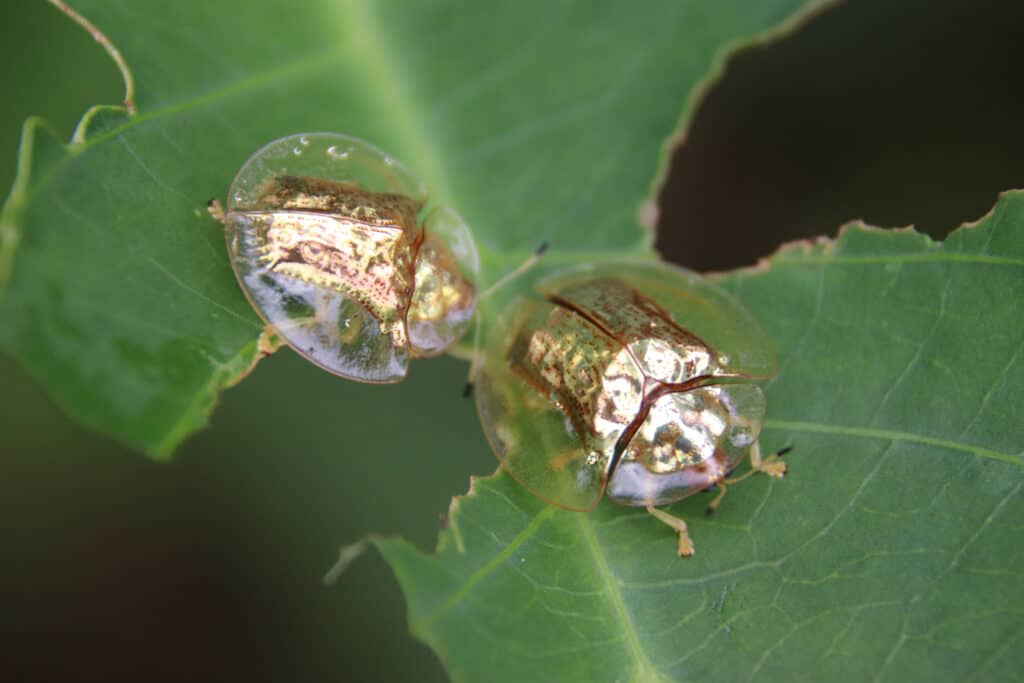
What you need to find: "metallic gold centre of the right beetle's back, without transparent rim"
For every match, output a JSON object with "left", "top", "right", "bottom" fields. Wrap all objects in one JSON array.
[{"left": 508, "top": 280, "right": 725, "bottom": 481}]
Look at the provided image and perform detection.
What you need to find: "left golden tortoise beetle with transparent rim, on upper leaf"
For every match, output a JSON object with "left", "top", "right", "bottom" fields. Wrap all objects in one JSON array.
[{"left": 210, "top": 133, "right": 479, "bottom": 383}]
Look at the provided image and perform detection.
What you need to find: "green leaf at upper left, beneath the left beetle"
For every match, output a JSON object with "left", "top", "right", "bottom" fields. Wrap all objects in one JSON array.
[{"left": 0, "top": 0, "right": 822, "bottom": 459}]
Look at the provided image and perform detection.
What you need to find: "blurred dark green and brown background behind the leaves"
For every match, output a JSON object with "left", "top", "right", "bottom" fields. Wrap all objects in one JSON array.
[{"left": 0, "top": 0, "right": 1024, "bottom": 681}]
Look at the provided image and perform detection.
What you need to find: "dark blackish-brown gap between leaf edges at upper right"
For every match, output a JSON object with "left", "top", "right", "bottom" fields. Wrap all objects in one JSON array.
[{"left": 658, "top": 0, "right": 1024, "bottom": 270}]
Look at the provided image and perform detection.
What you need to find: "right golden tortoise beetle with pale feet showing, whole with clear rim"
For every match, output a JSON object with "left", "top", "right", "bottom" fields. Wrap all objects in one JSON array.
[{"left": 476, "top": 262, "right": 785, "bottom": 556}]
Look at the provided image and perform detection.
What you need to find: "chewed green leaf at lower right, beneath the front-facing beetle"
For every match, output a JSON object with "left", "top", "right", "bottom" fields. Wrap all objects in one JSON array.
[{"left": 378, "top": 191, "right": 1024, "bottom": 682}]
